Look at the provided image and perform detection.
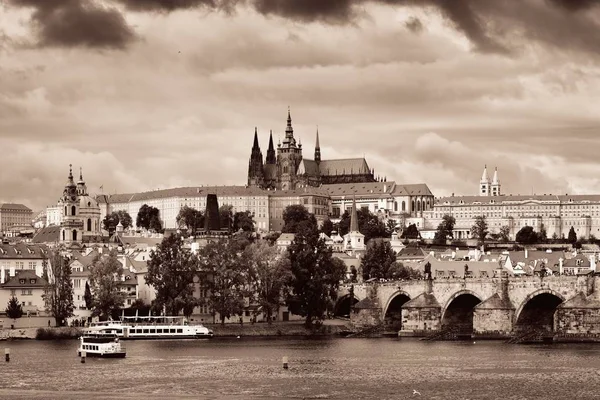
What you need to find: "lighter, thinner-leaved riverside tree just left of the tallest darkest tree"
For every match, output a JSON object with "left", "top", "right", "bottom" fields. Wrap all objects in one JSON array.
[{"left": 243, "top": 241, "right": 291, "bottom": 324}]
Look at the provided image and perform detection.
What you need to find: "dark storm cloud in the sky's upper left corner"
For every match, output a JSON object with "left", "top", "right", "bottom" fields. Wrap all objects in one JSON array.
[{"left": 9, "top": 0, "right": 135, "bottom": 48}]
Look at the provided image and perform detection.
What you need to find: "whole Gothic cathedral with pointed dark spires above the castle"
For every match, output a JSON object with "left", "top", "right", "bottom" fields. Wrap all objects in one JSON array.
[{"left": 248, "top": 110, "right": 375, "bottom": 190}]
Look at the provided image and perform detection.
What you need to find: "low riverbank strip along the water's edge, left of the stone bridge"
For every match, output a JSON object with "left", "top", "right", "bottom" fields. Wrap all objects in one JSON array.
[{"left": 0, "top": 321, "right": 350, "bottom": 341}]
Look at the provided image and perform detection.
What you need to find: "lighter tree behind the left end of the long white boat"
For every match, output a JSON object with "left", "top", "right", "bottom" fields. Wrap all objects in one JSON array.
[{"left": 89, "top": 250, "right": 125, "bottom": 319}]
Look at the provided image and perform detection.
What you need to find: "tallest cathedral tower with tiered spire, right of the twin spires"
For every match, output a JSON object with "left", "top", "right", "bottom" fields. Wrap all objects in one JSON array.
[{"left": 277, "top": 108, "right": 302, "bottom": 190}]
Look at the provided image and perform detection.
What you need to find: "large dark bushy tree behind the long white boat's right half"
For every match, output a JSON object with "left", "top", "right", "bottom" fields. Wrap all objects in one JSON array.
[{"left": 146, "top": 234, "right": 198, "bottom": 316}]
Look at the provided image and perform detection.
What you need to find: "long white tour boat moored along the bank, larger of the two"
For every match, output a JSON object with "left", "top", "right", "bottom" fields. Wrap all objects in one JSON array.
[{"left": 86, "top": 316, "right": 213, "bottom": 340}]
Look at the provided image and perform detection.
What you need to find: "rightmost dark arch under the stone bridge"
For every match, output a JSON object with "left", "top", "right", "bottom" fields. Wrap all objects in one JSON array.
[{"left": 514, "top": 288, "right": 565, "bottom": 331}]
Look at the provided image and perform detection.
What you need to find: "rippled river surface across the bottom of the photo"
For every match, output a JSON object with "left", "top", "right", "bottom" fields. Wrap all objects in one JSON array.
[{"left": 0, "top": 338, "right": 600, "bottom": 400}]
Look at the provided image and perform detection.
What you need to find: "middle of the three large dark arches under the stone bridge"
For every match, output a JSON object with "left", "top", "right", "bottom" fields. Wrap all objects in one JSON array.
[{"left": 441, "top": 289, "right": 483, "bottom": 333}]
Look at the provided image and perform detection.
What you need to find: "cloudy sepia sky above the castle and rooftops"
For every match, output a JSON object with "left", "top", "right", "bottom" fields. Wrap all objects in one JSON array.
[{"left": 0, "top": 0, "right": 600, "bottom": 211}]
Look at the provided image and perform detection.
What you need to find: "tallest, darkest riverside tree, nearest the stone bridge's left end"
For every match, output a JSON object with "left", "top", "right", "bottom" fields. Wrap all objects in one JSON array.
[{"left": 287, "top": 221, "right": 346, "bottom": 327}]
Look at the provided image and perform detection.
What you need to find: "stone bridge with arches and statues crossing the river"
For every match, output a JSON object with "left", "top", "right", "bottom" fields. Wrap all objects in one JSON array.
[{"left": 335, "top": 273, "right": 600, "bottom": 337}]
